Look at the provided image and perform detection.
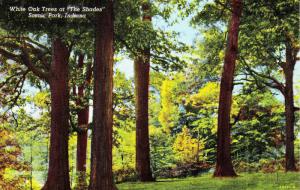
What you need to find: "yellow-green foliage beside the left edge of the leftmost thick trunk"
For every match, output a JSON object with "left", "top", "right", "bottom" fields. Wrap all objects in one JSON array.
[{"left": 0, "top": 88, "right": 50, "bottom": 189}]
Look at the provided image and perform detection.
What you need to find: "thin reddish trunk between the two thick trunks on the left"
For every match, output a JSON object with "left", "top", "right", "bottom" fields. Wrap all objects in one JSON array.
[{"left": 76, "top": 54, "right": 90, "bottom": 189}]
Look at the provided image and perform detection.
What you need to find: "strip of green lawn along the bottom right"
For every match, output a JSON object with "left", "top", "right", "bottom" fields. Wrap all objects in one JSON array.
[{"left": 117, "top": 172, "right": 300, "bottom": 190}]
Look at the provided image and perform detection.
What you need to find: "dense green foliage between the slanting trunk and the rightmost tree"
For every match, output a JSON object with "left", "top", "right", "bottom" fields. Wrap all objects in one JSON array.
[{"left": 232, "top": 86, "right": 284, "bottom": 162}]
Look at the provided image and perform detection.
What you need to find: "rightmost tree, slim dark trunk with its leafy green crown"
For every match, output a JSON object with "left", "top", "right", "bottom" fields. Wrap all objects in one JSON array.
[{"left": 237, "top": 1, "right": 300, "bottom": 171}]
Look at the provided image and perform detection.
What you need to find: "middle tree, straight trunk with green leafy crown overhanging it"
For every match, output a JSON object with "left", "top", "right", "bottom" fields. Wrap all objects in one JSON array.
[{"left": 115, "top": 1, "right": 188, "bottom": 181}]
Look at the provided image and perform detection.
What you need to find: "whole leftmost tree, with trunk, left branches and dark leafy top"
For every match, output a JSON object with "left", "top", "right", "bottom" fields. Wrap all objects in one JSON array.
[{"left": 0, "top": 1, "right": 95, "bottom": 189}]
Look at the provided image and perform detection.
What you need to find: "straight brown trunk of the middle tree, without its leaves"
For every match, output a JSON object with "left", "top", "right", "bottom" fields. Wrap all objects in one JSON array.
[{"left": 134, "top": 3, "right": 154, "bottom": 181}]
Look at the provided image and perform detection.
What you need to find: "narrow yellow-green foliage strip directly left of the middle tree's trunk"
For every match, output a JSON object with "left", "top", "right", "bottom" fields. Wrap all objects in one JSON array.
[{"left": 113, "top": 70, "right": 136, "bottom": 182}]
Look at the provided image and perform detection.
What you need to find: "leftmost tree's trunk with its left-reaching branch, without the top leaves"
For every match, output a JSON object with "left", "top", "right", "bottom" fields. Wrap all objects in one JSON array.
[{"left": 0, "top": 36, "right": 70, "bottom": 189}]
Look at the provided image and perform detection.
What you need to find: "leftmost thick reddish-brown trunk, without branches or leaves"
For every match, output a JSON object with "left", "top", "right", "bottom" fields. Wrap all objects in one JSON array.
[{"left": 43, "top": 38, "right": 70, "bottom": 190}]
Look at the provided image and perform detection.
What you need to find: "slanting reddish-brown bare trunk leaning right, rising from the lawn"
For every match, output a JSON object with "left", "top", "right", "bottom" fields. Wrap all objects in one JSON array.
[{"left": 214, "top": 0, "right": 242, "bottom": 177}]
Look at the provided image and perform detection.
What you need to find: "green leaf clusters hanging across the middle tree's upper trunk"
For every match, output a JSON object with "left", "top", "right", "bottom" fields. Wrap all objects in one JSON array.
[{"left": 114, "top": 0, "right": 188, "bottom": 71}]
